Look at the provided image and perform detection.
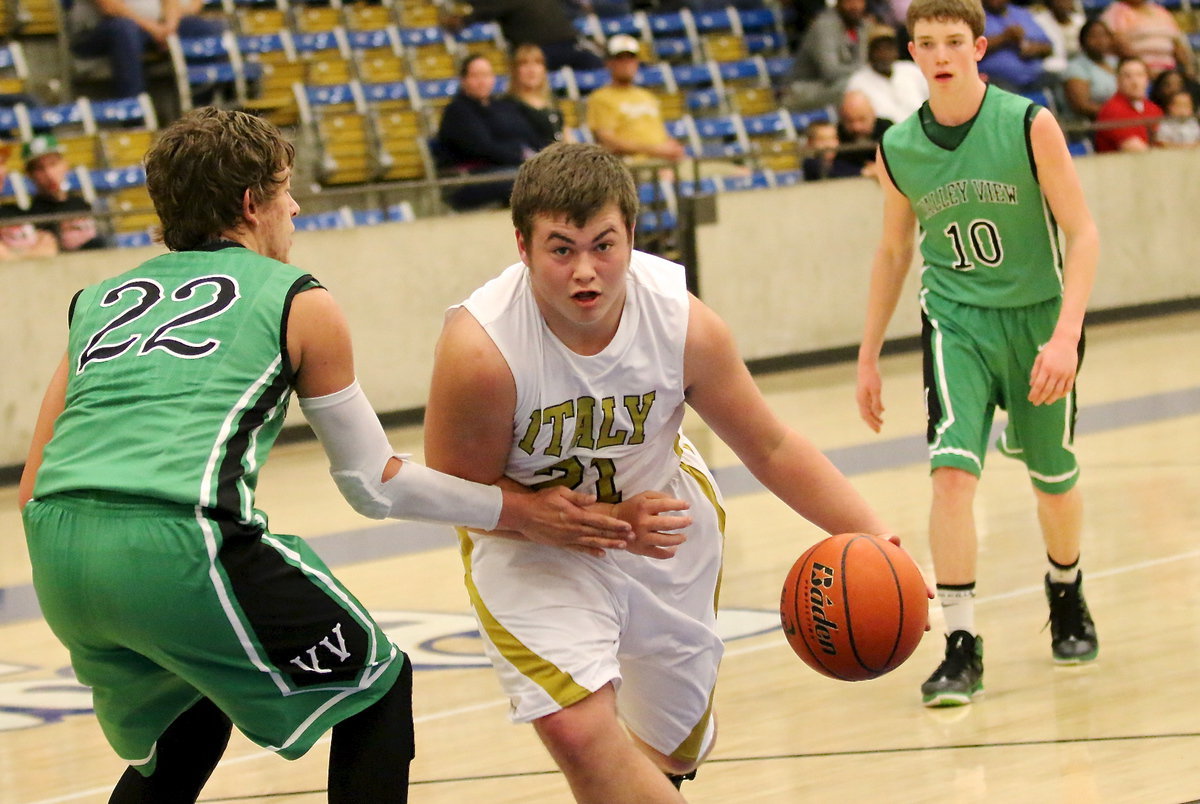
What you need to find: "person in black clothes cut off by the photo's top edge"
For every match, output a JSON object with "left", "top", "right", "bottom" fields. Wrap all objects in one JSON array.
[{"left": 443, "top": 0, "right": 604, "bottom": 70}]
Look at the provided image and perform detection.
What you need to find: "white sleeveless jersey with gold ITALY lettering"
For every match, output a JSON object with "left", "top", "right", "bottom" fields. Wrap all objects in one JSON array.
[{"left": 463, "top": 251, "right": 696, "bottom": 502}]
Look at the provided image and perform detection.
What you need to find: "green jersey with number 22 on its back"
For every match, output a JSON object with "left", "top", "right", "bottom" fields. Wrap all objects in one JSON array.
[{"left": 34, "top": 246, "right": 316, "bottom": 524}]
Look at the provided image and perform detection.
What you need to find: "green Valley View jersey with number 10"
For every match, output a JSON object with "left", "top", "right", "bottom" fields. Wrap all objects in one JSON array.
[{"left": 881, "top": 86, "right": 1062, "bottom": 307}]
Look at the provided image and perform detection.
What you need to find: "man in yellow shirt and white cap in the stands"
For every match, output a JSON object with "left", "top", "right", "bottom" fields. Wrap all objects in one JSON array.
[{"left": 587, "top": 34, "right": 684, "bottom": 162}]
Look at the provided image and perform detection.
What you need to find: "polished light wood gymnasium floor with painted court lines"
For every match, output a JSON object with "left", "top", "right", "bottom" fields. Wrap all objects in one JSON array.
[{"left": 0, "top": 312, "right": 1200, "bottom": 804}]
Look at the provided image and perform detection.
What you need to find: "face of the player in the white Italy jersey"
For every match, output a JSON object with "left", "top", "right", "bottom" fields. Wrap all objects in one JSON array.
[{"left": 517, "top": 204, "right": 632, "bottom": 354}]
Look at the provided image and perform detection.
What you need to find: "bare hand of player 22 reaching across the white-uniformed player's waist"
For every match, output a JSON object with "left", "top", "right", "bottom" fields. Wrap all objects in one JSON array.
[{"left": 504, "top": 486, "right": 632, "bottom": 556}]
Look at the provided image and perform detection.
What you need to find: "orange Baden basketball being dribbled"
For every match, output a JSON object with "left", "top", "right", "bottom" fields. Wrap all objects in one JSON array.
[{"left": 779, "top": 533, "right": 929, "bottom": 682}]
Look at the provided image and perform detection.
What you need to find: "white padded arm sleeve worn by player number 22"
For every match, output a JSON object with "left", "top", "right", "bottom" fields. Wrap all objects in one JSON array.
[{"left": 300, "top": 380, "right": 504, "bottom": 530}]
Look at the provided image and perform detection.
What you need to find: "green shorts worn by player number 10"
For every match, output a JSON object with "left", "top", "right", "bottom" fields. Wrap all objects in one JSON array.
[{"left": 920, "top": 290, "right": 1084, "bottom": 494}]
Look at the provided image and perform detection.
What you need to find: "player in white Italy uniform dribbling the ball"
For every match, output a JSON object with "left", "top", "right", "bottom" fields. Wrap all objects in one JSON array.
[{"left": 425, "top": 143, "right": 887, "bottom": 804}]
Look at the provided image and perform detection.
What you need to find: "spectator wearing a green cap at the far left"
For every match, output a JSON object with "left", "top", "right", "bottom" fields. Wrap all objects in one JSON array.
[{"left": 22, "top": 134, "right": 109, "bottom": 251}]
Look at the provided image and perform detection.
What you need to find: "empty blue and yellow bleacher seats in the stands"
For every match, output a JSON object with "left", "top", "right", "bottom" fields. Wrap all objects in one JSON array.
[{"left": 0, "top": 0, "right": 1132, "bottom": 245}]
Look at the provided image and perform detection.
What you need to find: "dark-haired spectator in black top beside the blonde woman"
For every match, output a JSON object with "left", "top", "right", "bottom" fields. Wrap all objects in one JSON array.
[{"left": 437, "top": 54, "right": 546, "bottom": 210}]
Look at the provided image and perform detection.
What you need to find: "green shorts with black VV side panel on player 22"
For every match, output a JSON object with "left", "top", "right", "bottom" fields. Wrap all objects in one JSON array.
[{"left": 24, "top": 492, "right": 406, "bottom": 774}]
